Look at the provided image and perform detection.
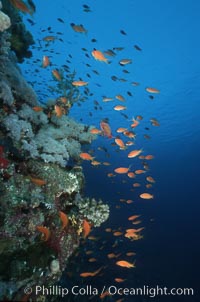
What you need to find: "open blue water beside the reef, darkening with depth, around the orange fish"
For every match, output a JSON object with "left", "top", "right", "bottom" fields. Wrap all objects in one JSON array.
[{"left": 19, "top": 0, "right": 200, "bottom": 302}]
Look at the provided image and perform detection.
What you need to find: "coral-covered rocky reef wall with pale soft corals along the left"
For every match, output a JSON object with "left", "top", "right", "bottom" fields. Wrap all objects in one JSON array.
[{"left": 0, "top": 1, "right": 109, "bottom": 301}]
